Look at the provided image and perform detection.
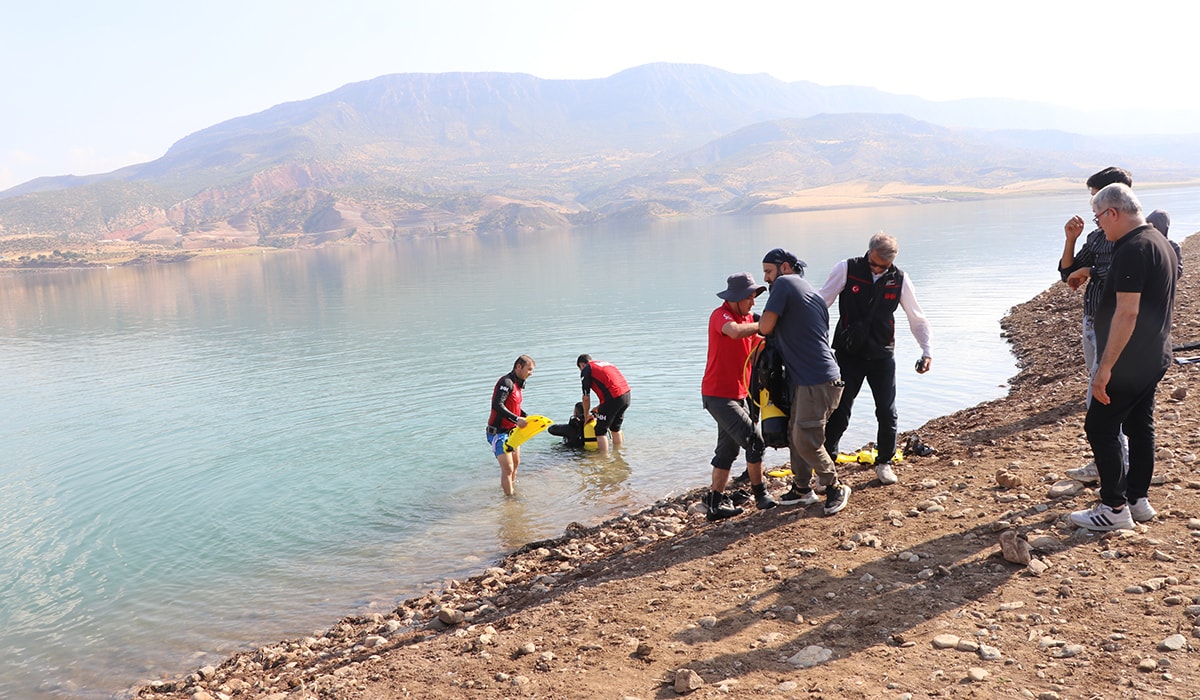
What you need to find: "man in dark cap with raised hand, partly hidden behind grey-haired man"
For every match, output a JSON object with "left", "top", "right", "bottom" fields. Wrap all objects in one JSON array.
[{"left": 1058, "top": 166, "right": 1133, "bottom": 483}]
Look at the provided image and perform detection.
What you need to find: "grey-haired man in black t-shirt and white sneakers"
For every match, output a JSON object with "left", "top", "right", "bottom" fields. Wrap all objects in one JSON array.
[{"left": 1070, "top": 184, "right": 1177, "bottom": 531}]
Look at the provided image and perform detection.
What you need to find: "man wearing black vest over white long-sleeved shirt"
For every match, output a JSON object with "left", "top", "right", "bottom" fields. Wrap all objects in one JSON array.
[{"left": 821, "top": 232, "right": 932, "bottom": 485}]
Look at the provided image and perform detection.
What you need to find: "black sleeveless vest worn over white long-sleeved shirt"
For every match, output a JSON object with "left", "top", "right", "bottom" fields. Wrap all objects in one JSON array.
[{"left": 833, "top": 256, "right": 904, "bottom": 359}]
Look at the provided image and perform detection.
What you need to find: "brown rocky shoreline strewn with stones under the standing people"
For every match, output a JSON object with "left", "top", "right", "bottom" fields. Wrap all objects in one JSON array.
[{"left": 131, "top": 235, "right": 1200, "bottom": 700}]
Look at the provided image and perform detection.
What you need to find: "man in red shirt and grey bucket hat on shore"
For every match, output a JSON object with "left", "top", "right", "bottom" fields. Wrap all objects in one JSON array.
[{"left": 700, "top": 273, "right": 775, "bottom": 520}]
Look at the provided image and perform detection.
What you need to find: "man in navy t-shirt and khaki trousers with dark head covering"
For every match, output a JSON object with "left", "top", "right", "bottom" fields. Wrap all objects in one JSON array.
[{"left": 758, "top": 249, "right": 850, "bottom": 515}]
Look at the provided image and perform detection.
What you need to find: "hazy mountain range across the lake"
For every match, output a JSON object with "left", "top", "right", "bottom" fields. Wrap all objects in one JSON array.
[{"left": 0, "top": 64, "right": 1200, "bottom": 249}]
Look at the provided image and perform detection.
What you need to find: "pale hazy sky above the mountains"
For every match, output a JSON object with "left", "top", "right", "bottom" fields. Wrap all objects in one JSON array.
[{"left": 0, "top": 0, "right": 1200, "bottom": 190}]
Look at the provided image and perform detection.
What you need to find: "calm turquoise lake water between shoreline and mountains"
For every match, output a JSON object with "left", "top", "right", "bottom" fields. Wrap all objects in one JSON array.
[{"left": 0, "top": 189, "right": 1200, "bottom": 698}]
